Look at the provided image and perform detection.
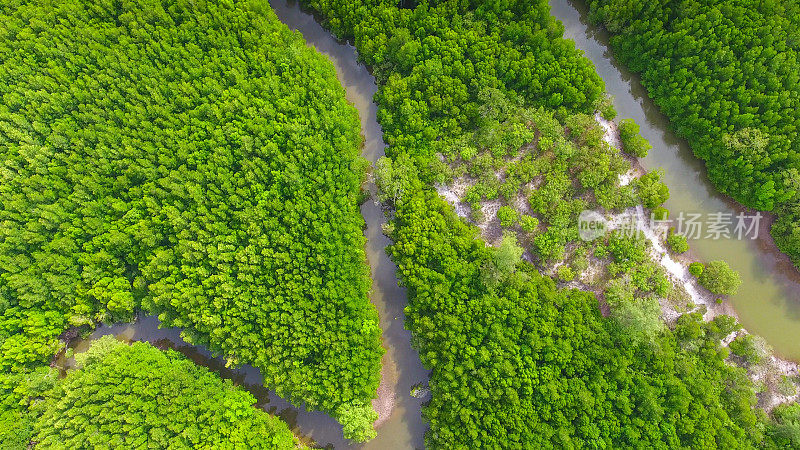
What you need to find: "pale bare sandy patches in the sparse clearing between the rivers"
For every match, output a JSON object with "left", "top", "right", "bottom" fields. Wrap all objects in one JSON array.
[{"left": 435, "top": 110, "right": 799, "bottom": 411}]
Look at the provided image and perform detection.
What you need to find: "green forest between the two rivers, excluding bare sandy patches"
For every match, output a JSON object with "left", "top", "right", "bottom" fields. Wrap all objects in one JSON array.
[{"left": 309, "top": 0, "right": 788, "bottom": 449}]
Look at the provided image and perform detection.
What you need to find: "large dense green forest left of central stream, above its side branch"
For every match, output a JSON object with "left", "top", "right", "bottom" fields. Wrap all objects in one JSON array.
[{"left": 0, "top": 0, "right": 382, "bottom": 440}]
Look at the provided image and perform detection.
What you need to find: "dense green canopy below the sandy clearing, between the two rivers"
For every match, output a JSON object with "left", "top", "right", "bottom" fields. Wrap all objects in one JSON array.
[{"left": 392, "top": 191, "right": 760, "bottom": 448}]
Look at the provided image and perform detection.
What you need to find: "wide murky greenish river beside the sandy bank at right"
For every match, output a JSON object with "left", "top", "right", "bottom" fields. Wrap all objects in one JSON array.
[{"left": 550, "top": 0, "right": 800, "bottom": 362}]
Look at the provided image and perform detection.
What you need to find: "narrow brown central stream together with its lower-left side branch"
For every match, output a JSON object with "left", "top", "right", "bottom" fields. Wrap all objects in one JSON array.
[{"left": 59, "top": 0, "right": 428, "bottom": 450}]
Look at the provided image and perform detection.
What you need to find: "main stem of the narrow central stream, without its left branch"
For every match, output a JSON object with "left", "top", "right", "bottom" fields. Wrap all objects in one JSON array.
[{"left": 270, "top": 0, "right": 428, "bottom": 450}]
